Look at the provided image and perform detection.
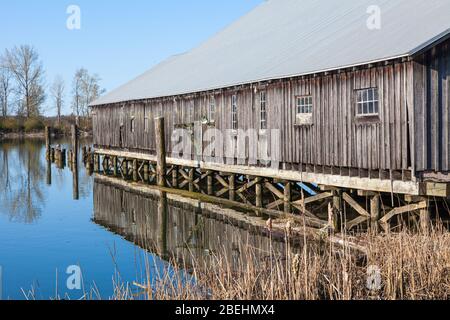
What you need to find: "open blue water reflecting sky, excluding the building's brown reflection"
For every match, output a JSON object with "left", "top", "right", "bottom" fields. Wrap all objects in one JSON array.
[{"left": 0, "top": 141, "right": 172, "bottom": 299}]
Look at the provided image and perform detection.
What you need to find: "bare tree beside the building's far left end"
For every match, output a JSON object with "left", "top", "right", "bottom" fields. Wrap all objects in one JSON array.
[{"left": 72, "top": 68, "right": 104, "bottom": 119}]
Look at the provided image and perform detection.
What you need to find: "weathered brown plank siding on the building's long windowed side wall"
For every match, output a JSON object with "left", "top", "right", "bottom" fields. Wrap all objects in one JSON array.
[{"left": 94, "top": 62, "right": 418, "bottom": 174}]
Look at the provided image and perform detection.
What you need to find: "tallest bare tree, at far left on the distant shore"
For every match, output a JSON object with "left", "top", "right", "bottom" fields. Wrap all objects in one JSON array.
[{"left": 5, "top": 45, "right": 45, "bottom": 117}]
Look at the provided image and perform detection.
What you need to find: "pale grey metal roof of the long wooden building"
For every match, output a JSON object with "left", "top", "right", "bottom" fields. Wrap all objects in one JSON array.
[{"left": 92, "top": 0, "right": 450, "bottom": 105}]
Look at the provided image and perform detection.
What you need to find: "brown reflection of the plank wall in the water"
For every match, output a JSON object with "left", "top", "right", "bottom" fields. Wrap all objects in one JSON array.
[{"left": 94, "top": 178, "right": 298, "bottom": 265}]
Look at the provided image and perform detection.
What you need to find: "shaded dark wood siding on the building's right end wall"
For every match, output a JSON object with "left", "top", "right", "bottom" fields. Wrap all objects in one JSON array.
[{"left": 414, "top": 41, "right": 450, "bottom": 172}]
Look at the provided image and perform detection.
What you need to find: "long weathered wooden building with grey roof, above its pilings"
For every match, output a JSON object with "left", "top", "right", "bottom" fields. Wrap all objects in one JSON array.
[{"left": 91, "top": 0, "right": 450, "bottom": 230}]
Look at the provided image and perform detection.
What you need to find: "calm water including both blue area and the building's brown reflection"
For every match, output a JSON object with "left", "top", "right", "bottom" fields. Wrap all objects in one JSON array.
[{"left": 0, "top": 141, "right": 284, "bottom": 299}]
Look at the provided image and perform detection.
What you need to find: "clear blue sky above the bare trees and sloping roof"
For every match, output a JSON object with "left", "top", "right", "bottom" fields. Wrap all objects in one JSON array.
[{"left": 0, "top": 0, "right": 264, "bottom": 115}]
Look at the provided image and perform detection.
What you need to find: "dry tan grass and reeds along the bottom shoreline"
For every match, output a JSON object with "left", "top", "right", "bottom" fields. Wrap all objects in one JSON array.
[{"left": 120, "top": 230, "right": 450, "bottom": 300}]
